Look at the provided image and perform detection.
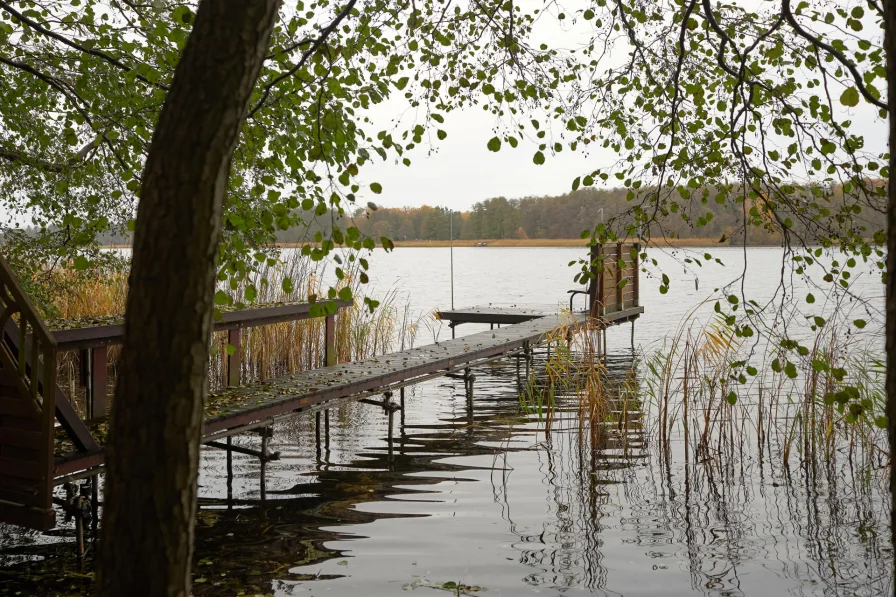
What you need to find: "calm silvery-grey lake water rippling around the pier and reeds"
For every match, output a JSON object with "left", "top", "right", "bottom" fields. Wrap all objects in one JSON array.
[{"left": 0, "top": 248, "right": 894, "bottom": 597}]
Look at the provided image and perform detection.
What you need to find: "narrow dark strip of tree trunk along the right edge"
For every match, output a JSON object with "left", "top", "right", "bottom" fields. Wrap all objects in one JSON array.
[{"left": 883, "top": 0, "right": 896, "bottom": 597}]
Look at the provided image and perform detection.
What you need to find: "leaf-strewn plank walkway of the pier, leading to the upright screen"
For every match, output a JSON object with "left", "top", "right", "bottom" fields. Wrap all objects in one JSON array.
[{"left": 205, "top": 314, "right": 588, "bottom": 435}]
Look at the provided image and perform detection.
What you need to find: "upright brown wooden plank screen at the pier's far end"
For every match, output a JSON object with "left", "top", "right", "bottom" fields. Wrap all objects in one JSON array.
[{"left": 588, "top": 243, "right": 641, "bottom": 317}]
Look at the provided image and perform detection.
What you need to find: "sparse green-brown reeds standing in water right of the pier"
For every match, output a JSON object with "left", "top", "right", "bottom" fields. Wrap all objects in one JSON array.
[{"left": 642, "top": 308, "right": 889, "bottom": 467}]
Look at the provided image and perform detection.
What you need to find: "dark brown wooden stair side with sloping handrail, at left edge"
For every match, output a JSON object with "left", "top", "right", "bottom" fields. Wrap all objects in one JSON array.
[{"left": 0, "top": 257, "right": 56, "bottom": 529}]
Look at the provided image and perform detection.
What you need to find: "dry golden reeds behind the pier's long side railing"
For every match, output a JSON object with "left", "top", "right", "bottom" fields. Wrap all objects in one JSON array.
[{"left": 45, "top": 250, "right": 419, "bottom": 412}]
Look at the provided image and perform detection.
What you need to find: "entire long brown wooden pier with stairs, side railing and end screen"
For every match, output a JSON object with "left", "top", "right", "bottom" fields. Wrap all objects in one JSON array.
[{"left": 0, "top": 240, "right": 643, "bottom": 530}]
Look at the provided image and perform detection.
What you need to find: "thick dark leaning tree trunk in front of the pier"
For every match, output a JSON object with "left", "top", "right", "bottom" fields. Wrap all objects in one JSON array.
[{"left": 99, "top": 0, "right": 279, "bottom": 597}]
